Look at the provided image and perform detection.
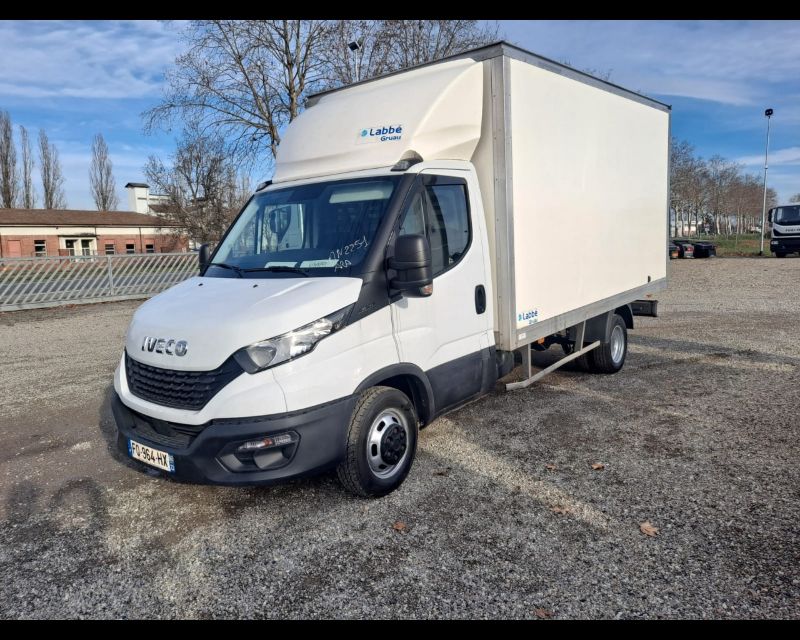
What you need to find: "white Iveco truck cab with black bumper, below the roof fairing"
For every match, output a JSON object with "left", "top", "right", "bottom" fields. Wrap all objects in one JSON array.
[{"left": 114, "top": 161, "right": 498, "bottom": 493}]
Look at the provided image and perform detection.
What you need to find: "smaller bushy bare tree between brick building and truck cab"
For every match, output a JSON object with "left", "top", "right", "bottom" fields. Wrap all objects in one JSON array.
[{"left": 144, "top": 125, "right": 251, "bottom": 242}]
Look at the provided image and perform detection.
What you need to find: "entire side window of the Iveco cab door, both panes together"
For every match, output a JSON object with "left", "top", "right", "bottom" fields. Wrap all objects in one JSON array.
[{"left": 399, "top": 182, "right": 471, "bottom": 277}]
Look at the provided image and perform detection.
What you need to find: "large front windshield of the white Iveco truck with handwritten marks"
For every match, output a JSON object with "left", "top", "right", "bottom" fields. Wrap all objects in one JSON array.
[{"left": 206, "top": 176, "right": 400, "bottom": 278}]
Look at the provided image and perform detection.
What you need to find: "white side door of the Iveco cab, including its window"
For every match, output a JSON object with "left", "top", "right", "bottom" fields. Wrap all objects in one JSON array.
[{"left": 392, "top": 171, "right": 492, "bottom": 413}]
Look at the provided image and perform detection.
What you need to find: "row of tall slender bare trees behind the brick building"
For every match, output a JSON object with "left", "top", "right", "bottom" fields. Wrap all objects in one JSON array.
[{"left": 0, "top": 111, "right": 119, "bottom": 211}]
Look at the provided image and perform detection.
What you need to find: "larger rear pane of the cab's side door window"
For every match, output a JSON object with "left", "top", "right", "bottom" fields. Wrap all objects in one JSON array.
[{"left": 426, "top": 184, "right": 470, "bottom": 277}]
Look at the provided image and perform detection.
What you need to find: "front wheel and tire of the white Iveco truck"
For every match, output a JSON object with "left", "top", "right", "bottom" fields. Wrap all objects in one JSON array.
[{"left": 336, "top": 387, "right": 419, "bottom": 498}]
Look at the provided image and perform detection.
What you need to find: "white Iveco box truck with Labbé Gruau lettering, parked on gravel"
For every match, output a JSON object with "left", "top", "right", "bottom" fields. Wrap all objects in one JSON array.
[{"left": 113, "top": 43, "right": 669, "bottom": 496}]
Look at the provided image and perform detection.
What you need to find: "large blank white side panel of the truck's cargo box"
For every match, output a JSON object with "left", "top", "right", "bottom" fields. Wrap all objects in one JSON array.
[{"left": 506, "top": 59, "right": 669, "bottom": 346}]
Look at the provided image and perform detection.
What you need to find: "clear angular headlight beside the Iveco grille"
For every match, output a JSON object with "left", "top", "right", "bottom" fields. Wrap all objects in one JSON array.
[{"left": 233, "top": 304, "right": 353, "bottom": 373}]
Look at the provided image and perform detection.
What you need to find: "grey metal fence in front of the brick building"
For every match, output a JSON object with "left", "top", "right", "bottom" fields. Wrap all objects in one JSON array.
[{"left": 0, "top": 253, "right": 198, "bottom": 311}]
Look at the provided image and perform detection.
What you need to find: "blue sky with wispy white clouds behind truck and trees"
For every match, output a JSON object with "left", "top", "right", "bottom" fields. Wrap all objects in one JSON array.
[{"left": 0, "top": 20, "right": 800, "bottom": 209}]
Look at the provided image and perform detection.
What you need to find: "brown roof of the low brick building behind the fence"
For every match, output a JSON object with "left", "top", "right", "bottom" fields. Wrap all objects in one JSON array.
[{"left": 0, "top": 209, "right": 179, "bottom": 227}]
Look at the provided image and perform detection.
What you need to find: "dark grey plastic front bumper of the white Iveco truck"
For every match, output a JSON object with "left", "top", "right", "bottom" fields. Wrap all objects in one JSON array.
[{"left": 111, "top": 393, "right": 356, "bottom": 485}]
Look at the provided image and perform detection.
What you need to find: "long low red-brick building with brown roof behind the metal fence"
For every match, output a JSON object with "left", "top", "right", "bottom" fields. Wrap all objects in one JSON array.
[{"left": 0, "top": 209, "right": 188, "bottom": 258}]
